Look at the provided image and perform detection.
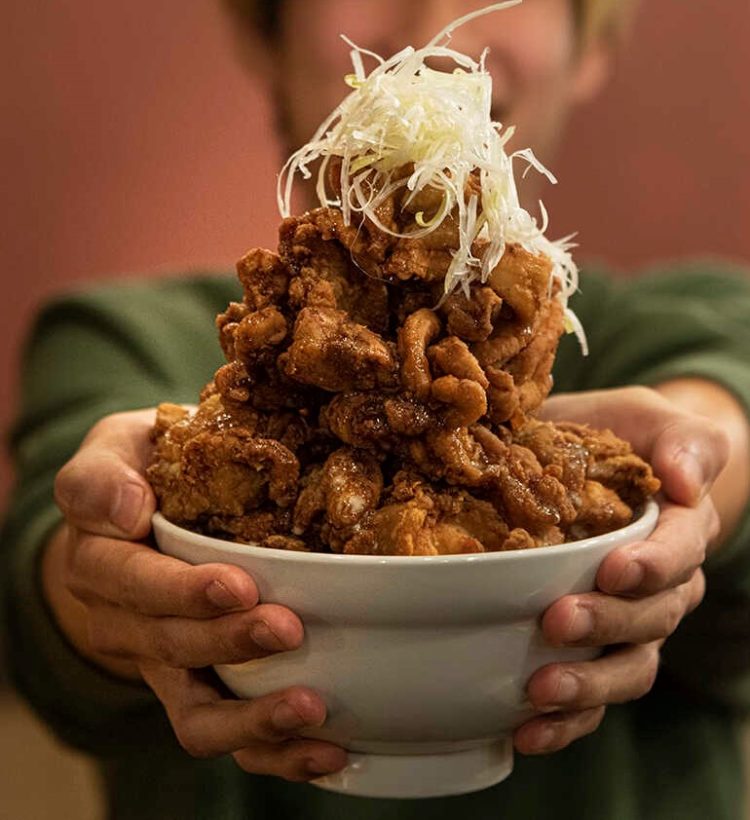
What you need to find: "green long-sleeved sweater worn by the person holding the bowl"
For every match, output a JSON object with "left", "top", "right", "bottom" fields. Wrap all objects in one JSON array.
[{"left": 0, "top": 264, "right": 750, "bottom": 820}]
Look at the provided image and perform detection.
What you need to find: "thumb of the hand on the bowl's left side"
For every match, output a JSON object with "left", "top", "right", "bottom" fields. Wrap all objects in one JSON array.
[{"left": 55, "top": 410, "right": 156, "bottom": 540}]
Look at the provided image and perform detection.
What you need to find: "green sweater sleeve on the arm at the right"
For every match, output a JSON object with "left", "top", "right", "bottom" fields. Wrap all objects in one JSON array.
[{"left": 555, "top": 263, "right": 750, "bottom": 710}]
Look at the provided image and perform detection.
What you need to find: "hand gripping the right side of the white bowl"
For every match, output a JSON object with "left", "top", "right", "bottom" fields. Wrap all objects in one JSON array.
[{"left": 514, "top": 387, "right": 729, "bottom": 754}]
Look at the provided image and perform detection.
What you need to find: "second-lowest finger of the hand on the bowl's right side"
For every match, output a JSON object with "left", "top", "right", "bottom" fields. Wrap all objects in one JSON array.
[{"left": 526, "top": 641, "right": 661, "bottom": 712}]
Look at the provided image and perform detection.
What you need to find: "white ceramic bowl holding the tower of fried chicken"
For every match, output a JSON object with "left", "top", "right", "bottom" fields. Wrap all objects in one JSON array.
[{"left": 154, "top": 501, "right": 659, "bottom": 797}]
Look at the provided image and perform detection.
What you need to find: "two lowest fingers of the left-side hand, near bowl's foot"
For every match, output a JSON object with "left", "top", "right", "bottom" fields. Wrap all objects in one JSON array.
[{"left": 142, "top": 665, "right": 346, "bottom": 780}]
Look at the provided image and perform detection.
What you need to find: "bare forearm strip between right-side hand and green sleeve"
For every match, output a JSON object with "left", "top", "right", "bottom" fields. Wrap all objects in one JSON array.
[{"left": 655, "top": 379, "right": 750, "bottom": 545}]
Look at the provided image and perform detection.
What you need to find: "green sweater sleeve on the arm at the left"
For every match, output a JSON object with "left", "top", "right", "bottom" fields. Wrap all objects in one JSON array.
[{"left": 0, "top": 276, "right": 237, "bottom": 753}]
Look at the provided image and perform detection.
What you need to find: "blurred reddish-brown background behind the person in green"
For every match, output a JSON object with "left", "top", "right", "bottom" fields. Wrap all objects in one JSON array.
[{"left": 0, "top": 0, "right": 750, "bottom": 820}]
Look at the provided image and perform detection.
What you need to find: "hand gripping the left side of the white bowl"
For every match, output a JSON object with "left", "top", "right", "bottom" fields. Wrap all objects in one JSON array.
[{"left": 48, "top": 410, "right": 346, "bottom": 780}]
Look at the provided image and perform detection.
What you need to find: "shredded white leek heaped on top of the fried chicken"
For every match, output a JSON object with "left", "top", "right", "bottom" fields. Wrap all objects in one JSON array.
[{"left": 278, "top": 0, "right": 586, "bottom": 352}]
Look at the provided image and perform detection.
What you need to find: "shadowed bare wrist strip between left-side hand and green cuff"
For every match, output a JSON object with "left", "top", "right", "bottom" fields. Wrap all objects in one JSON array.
[{"left": 41, "top": 525, "right": 141, "bottom": 681}]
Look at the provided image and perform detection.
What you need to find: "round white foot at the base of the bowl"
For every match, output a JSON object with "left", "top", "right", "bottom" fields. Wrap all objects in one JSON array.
[{"left": 312, "top": 738, "right": 513, "bottom": 798}]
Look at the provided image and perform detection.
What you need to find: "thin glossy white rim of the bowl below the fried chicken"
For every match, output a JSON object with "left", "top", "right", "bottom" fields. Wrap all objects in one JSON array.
[{"left": 156, "top": 498, "right": 660, "bottom": 568}]
